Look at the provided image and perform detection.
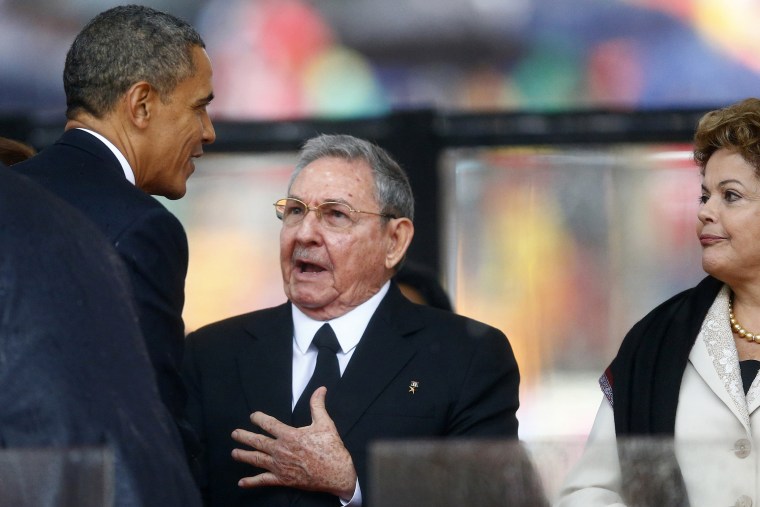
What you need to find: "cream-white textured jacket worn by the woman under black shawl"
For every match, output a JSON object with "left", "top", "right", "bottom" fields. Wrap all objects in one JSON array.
[{"left": 555, "top": 286, "right": 760, "bottom": 507}]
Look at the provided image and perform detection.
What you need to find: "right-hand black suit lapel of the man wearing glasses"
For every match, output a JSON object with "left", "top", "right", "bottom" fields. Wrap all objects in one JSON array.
[{"left": 328, "top": 284, "right": 422, "bottom": 438}]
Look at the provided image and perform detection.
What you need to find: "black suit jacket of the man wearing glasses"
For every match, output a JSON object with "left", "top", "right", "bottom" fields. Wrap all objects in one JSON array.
[{"left": 184, "top": 284, "right": 519, "bottom": 507}]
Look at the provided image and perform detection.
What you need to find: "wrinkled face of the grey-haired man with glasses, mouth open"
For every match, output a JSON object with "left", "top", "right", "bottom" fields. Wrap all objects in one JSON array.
[{"left": 280, "top": 157, "right": 390, "bottom": 320}]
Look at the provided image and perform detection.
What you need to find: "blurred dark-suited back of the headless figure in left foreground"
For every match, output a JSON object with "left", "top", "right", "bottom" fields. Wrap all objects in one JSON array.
[{"left": 0, "top": 165, "right": 201, "bottom": 507}]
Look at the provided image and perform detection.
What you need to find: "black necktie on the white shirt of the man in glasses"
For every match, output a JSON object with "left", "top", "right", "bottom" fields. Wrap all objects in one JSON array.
[{"left": 293, "top": 324, "right": 340, "bottom": 427}]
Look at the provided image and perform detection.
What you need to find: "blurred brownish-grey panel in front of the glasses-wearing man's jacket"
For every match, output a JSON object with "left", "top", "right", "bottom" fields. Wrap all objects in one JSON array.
[{"left": 370, "top": 440, "right": 549, "bottom": 507}]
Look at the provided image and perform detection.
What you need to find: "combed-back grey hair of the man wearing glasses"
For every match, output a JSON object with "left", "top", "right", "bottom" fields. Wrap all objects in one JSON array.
[{"left": 288, "top": 134, "right": 414, "bottom": 220}]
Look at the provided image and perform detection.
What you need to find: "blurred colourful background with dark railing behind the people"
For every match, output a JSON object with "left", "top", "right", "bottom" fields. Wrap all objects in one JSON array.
[{"left": 0, "top": 0, "right": 760, "bottom": 441}]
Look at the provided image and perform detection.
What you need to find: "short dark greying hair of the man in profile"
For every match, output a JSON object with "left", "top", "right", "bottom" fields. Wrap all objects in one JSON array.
[{"left": 63, "top": 5, "right": 206, "bottom": 119}]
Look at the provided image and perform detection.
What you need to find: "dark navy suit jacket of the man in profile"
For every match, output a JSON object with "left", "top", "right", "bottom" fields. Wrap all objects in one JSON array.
[{"left": 12, "top": 130, "right": 197, "bottom": 460}]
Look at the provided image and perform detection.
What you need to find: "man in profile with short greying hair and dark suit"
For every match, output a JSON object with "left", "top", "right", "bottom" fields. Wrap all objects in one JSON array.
[{"left": 13, "top": 5, "right": 215, "bottom": 472}]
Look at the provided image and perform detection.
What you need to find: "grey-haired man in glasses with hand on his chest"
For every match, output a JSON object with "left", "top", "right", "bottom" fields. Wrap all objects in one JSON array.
[{"left": 185, "top": 136, "right": 519, "bottom": 507}]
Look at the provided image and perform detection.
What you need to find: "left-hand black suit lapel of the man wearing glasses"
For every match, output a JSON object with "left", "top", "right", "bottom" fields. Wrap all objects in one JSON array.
[{"left": 237, "top": 303, "right": 293, "bottom": 424}]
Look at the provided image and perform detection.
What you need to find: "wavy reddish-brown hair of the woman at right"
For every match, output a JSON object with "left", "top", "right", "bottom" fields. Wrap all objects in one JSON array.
[{"left": 694, "top": 98, "right": 760, "bottom": 177}]
